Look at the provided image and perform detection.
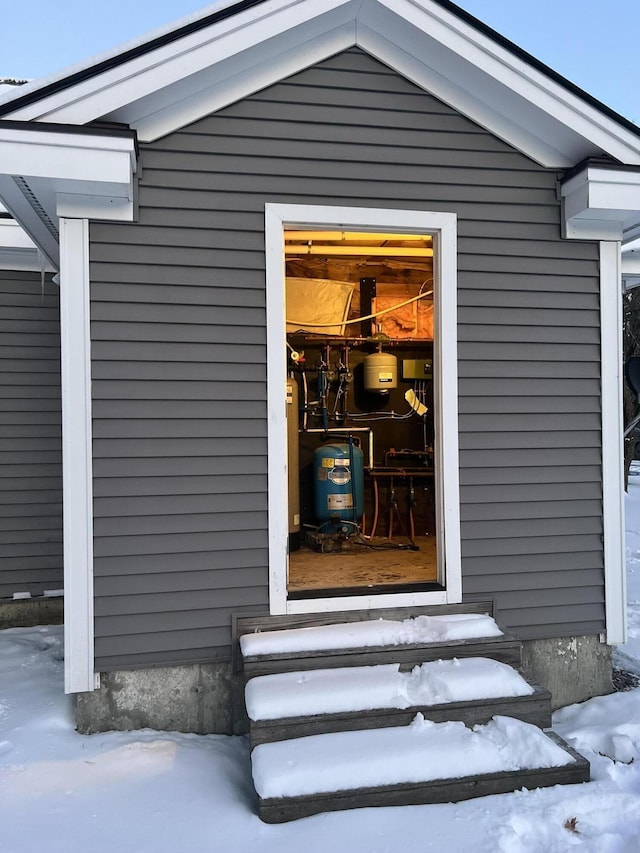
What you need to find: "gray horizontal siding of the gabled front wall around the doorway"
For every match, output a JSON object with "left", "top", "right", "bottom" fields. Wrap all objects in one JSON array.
[{"left": 91, "top": 50, "right": 604, "bottom": 669}]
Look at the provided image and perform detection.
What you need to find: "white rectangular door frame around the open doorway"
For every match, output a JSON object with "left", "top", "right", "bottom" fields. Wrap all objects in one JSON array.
[{"left": 265, "top": 204, "right": 462, "bottom": 615}]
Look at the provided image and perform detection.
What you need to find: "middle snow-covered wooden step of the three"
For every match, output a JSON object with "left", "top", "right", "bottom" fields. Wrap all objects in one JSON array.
[{"left": 245, "top": 658, "right": 551, "bottom": 747}]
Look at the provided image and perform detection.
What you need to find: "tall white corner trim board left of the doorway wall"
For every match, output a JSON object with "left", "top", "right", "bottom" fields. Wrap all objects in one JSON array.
[{"left": 60, "top": 218, "right": 95, "bottom": 693}]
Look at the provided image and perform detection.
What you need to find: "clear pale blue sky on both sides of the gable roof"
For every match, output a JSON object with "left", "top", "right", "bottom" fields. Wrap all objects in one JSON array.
[{"left": 0, "top": 0, "right": 640, "bottom": 123}]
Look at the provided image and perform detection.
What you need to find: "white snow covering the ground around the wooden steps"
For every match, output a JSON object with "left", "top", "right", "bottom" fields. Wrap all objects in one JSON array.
[{"left": 0, "top": 467, "right": 640, "bottom": 853}]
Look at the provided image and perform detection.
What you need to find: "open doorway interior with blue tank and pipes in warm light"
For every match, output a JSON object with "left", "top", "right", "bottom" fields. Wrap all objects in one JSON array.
[{"left": 284, "top": 227, "right": 443, "bottom": 600}]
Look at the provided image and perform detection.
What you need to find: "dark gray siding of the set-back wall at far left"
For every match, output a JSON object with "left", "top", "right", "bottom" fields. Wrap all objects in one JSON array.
[{"left": 0, "top": 270, "right": 63, "bottom": 599}]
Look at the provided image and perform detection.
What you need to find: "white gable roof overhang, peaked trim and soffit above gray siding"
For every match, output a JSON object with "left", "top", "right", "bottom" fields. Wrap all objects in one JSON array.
[{"left": 1, "top": 0, "right": 640, "bottom": 168}]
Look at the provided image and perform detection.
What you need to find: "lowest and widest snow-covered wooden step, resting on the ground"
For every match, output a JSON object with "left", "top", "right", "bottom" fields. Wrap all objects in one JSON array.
[{"left": 251, "top": 715, "right": 589, "bottom": 823}]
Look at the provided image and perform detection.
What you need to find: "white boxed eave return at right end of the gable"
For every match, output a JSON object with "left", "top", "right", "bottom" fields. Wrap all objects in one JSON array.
[{"left": 560, "top": 165, "right": 640, "bottom": 241}]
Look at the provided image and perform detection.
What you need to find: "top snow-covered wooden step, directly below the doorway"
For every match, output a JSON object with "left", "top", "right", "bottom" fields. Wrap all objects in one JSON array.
[{"left": 238, "top": 612, "right": 521, "bottom": 677}]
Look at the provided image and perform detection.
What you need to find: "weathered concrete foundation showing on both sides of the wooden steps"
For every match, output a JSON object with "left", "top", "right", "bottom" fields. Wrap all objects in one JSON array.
[{"left": 77, "top": 637, "right": 613, "bottom": 734}]
